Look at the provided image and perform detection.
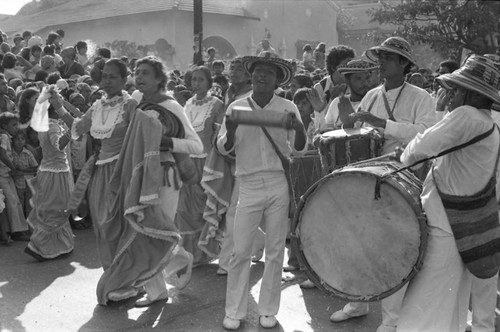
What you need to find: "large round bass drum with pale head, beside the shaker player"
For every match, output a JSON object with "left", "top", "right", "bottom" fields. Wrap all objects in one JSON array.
[{"left": 291, "top": 161, "right": 427, "bottom": 302}]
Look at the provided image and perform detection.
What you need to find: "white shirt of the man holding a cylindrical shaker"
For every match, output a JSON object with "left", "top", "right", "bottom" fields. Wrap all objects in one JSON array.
[{"left": 217, "top": 95, "right": 307, "bottom": 177}]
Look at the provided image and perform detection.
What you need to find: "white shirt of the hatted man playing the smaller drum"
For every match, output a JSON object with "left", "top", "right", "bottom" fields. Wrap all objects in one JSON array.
[{"left": 359, "top": 83, "right": 436, "bottom": 154}]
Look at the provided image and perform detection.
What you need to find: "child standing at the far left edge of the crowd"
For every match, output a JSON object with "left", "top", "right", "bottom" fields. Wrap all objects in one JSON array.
[{"left": 0, "top": 112, "right": 30, "bottom": 241}]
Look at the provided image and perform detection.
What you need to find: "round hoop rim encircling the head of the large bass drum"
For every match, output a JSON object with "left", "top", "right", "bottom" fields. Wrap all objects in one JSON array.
[{"left": 290, "top": 163, "right": 427, "bottom": 302}]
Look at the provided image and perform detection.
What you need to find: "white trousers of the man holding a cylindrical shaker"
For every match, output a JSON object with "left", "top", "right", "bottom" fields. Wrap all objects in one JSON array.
[{"left": 225, "top": 172, "right": 290, "bottom": 319}]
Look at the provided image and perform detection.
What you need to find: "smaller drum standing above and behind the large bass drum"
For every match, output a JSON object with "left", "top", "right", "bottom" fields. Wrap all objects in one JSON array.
[{"left": 314, "top": 128, "right": 384, "bottom": 175}]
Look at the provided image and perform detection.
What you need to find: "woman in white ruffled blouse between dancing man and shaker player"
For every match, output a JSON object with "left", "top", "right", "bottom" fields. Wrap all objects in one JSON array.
[{"left": 175, "top": 66, "right": 224, "bottom": 265}]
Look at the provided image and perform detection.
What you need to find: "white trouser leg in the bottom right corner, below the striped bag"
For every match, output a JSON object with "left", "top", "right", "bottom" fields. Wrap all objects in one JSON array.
[{"left": 470, "top": 274, "right": 498, "bottom": 332}]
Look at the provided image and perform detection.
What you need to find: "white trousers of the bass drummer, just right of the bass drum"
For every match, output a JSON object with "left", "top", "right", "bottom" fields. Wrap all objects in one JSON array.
[{"left": 397, "top": 228, "right": 472, "bottom": 332}]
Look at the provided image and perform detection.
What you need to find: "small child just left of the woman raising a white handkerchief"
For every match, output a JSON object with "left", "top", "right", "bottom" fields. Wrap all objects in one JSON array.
[{"left": 12, "top": 131, "right": 38, "bottom": 218}]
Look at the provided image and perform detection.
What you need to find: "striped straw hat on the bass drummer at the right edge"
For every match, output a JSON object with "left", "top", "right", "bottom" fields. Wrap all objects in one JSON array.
[{"left": 436, "top": 55, "right": 500, "bottom": 103}]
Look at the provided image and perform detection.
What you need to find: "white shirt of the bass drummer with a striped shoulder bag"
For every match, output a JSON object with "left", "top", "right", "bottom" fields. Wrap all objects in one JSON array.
[{"left": 401, "top": 106, "right": 500, "bottom": 234}]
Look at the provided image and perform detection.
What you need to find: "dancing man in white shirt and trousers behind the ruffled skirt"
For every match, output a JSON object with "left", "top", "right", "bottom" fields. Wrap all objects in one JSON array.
[{"left": 127, "top": 56, "right": 203, "bottom": 307}]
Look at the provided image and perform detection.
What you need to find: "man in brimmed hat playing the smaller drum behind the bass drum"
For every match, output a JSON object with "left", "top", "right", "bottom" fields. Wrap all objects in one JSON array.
[{"left": 330, "top": 37, "right": 435, "bottom": 332}]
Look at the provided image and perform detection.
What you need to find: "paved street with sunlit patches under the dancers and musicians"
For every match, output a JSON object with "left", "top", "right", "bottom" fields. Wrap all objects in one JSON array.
[{"left": 0, "top": 230, "right": 381, "bottom": 332}]
